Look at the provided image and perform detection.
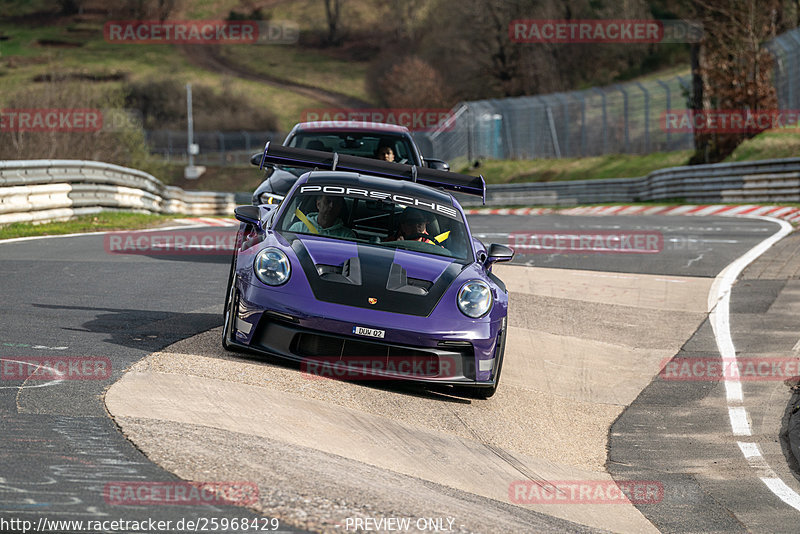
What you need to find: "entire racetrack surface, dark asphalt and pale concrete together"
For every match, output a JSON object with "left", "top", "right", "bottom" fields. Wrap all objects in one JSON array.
[{"left": 0, "top": 215, "right": 800, "bottom": 532}]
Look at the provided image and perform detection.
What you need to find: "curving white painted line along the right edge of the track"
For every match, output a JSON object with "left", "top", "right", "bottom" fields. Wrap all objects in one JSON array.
[{"left": 708, "top": 215, "right": 800, "bottom": 511}]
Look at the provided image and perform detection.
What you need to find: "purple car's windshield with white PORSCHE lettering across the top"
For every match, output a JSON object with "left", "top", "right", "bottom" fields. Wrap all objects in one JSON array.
[{"left": 274, "top": 184, "right": 472, "bottom": 261}]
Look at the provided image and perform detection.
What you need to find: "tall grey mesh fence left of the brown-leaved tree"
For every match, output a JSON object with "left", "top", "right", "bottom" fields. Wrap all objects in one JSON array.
[{"left": 417, "top": 75, "right": 692, "bottom": 161}]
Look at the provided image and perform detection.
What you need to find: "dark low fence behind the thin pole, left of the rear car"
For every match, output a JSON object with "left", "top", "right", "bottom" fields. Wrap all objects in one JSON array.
[{"left": 145, "top": 130, "right": 286, "bottom": 166}]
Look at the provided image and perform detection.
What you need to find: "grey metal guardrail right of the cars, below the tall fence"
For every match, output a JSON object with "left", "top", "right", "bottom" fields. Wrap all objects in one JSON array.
[{"left": 459, "top": 158, "right": 800, "bottom": 206}]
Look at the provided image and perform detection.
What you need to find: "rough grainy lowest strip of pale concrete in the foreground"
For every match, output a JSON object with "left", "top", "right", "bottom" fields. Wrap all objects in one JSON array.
[{"left": 117, "top": 418, "right": 603, "bottom": 533}]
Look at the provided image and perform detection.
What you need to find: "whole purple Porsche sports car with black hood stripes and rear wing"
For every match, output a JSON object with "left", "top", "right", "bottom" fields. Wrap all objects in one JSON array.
[{"left": 223, "top": 143, "right": 514, "bottom": 398}]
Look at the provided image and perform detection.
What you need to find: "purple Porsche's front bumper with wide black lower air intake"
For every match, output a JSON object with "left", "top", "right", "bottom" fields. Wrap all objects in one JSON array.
[{"left": 231, "top": 283, "right": 502, "bottom": 387}]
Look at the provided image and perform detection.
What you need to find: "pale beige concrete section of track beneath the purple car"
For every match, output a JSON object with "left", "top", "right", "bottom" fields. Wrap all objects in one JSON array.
[{"left": 106, "top": 266, "right": 712, "bottom": 532}]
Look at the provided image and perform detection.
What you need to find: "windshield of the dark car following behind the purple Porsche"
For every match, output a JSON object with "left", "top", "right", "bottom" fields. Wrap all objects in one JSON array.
[{"left": 288, "top": 131, "right": 419, "bottom": 165}]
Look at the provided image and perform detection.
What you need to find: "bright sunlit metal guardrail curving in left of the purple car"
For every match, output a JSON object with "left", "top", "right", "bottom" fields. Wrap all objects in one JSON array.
[{"left": 0, "top": 160, "right": 236, "bottom": 224}]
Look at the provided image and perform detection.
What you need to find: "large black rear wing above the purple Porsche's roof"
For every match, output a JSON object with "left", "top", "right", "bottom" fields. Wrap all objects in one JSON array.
[{"left": 256, "top": 142, "right": 486, "bottom": 204}]
